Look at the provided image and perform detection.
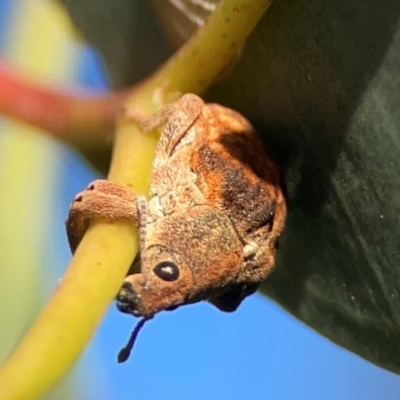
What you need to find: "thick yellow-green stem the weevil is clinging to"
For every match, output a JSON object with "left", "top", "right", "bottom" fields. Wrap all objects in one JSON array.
[{"left": 0, "top": 0, "right": 270, "bottom": 400}]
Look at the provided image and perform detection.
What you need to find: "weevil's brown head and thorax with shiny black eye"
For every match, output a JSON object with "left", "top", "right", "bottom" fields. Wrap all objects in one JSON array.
[{"left": 117, "top": 206, "right": 243, "bottom": 318}]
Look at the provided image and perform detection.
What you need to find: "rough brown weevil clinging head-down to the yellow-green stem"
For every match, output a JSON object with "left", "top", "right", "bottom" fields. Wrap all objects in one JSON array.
[{"left": 67, "top": 94, "right": 286, "bottom": 318}]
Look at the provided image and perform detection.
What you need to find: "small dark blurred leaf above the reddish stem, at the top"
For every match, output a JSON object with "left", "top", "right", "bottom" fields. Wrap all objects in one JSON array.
[{"left": 61, "top": 0, "right": 168, "bottom": 88}]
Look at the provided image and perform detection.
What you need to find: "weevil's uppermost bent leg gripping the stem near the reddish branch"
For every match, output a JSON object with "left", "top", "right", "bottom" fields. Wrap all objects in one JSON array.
[{"left": 126, "top": 93, "right": 204, "bottom": 157}]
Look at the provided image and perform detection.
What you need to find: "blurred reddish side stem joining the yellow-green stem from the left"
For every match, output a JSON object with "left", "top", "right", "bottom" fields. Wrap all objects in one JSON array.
[{"left": 0, "top": 60, "right": 129, "bottom": 149}]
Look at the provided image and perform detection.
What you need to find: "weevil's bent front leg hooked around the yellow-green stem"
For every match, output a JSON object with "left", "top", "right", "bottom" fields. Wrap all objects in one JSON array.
[{"left": 66, "top": 180, "right": 142, "bottom": 253}]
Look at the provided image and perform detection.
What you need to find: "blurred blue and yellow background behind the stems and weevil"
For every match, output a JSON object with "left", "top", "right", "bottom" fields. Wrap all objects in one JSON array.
[{"left": 0, "top": 0, "right": 400, "bottom": 400}]
